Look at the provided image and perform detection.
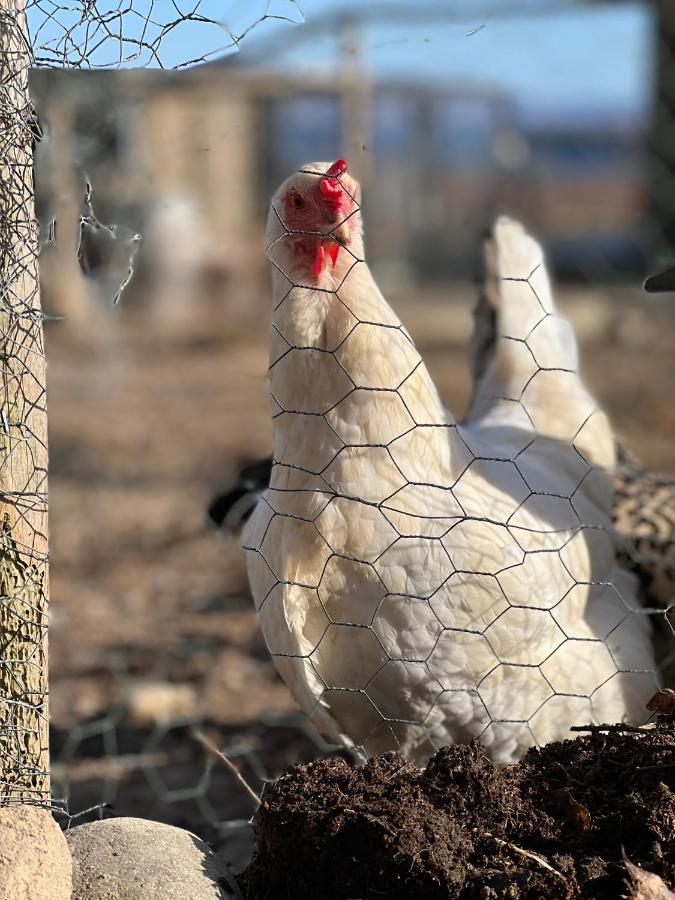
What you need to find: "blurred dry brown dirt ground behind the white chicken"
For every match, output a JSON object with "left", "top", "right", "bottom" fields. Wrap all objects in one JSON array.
[{"left": 47, "top": 287, "right": 675, "bottom": 864}]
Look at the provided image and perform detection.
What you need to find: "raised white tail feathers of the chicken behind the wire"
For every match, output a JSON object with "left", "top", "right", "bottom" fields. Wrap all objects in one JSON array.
[{"left": 467, "top": 216, "right": 615, "bottom": 467}]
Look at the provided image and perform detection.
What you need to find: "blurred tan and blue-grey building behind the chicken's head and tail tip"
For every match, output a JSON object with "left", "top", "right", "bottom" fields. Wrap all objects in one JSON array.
[{"left": 33, "top": 63, "right": 645, "bottom": 329}]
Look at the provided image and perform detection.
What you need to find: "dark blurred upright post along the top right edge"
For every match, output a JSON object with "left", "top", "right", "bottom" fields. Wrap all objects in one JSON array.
[{"left": 647, "top": 0, "right": 675, "bottom": 265}]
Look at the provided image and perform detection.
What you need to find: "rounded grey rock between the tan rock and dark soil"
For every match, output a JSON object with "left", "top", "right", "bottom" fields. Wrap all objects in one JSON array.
[{"left": 66, "top": 818, "right": 241, "bottom": 900}]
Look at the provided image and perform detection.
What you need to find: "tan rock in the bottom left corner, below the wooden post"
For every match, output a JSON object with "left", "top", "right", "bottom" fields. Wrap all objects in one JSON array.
[{"left": 0, "top": 805, "right": 72, "bottom": 900}]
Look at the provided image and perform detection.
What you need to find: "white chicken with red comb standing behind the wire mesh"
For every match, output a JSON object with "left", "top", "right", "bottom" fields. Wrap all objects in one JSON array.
[{"left": 243, "top": 160, "right": 655, "bottom": 763}]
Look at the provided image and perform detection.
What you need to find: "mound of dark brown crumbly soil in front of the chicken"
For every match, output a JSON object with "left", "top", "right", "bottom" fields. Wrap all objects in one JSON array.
[{"left": 241, "top": 692, "right": 675, "bottom": 900}]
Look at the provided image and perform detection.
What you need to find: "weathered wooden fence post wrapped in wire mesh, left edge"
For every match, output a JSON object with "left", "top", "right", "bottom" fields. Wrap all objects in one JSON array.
[{"left": 0, "top": 0, "right": 49, "bottom": 805}]
